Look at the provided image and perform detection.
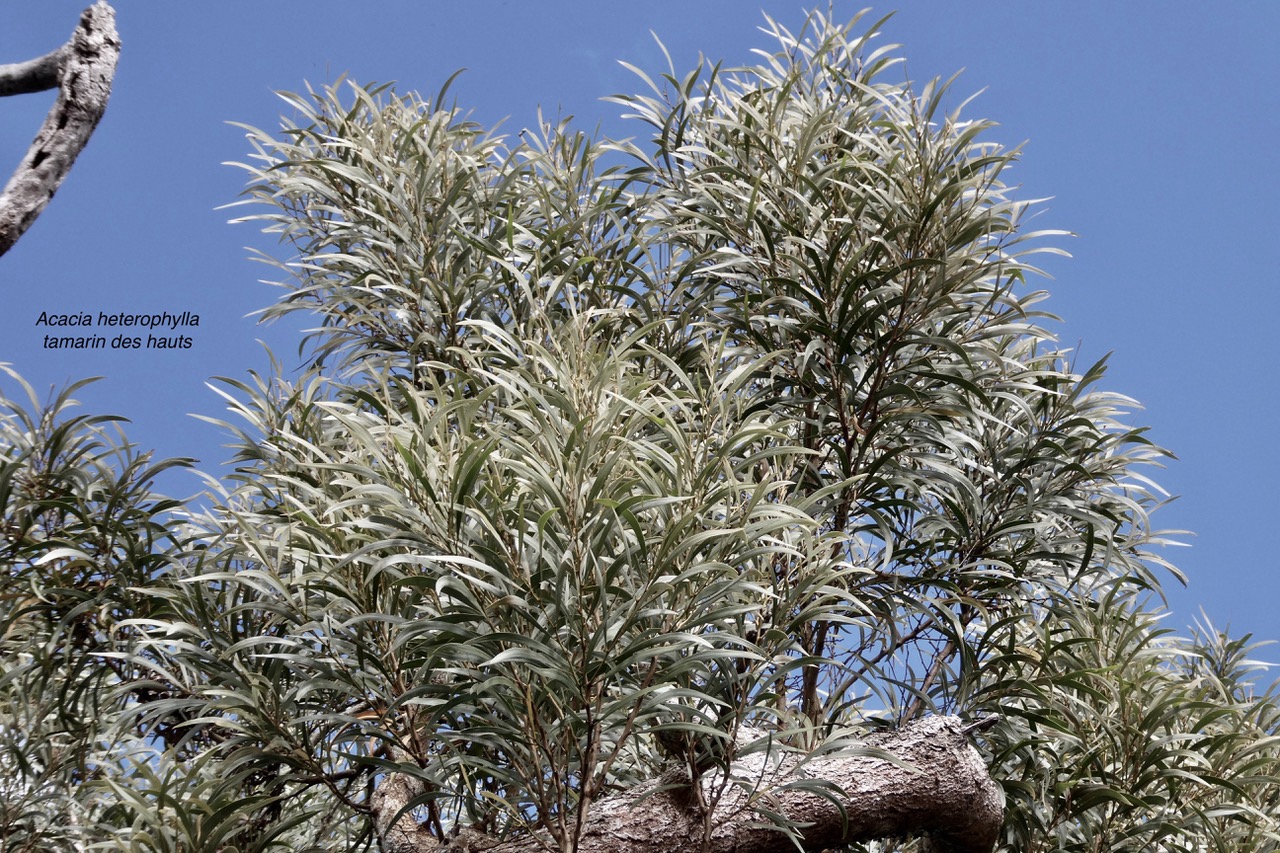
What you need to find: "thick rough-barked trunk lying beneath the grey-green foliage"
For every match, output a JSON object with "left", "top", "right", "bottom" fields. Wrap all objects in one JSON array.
[{"left": 372, "top": 717, "right": 1004, "bottom": 853}]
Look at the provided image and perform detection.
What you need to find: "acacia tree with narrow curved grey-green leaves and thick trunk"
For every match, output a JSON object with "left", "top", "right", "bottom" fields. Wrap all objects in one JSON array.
[{"left": 0, "top": 14, "right": 1280, "bottom": 853}]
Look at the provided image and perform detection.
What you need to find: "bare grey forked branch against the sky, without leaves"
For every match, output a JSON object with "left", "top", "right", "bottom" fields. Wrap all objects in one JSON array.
[{"left": 0, "top": 1, "right": 120, "bottom": 255}]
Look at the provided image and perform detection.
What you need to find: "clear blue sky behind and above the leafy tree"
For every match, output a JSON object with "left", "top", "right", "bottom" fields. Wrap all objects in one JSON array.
[{"left": 0, "top": 0, "right": 1280, "bottom": 648}]
